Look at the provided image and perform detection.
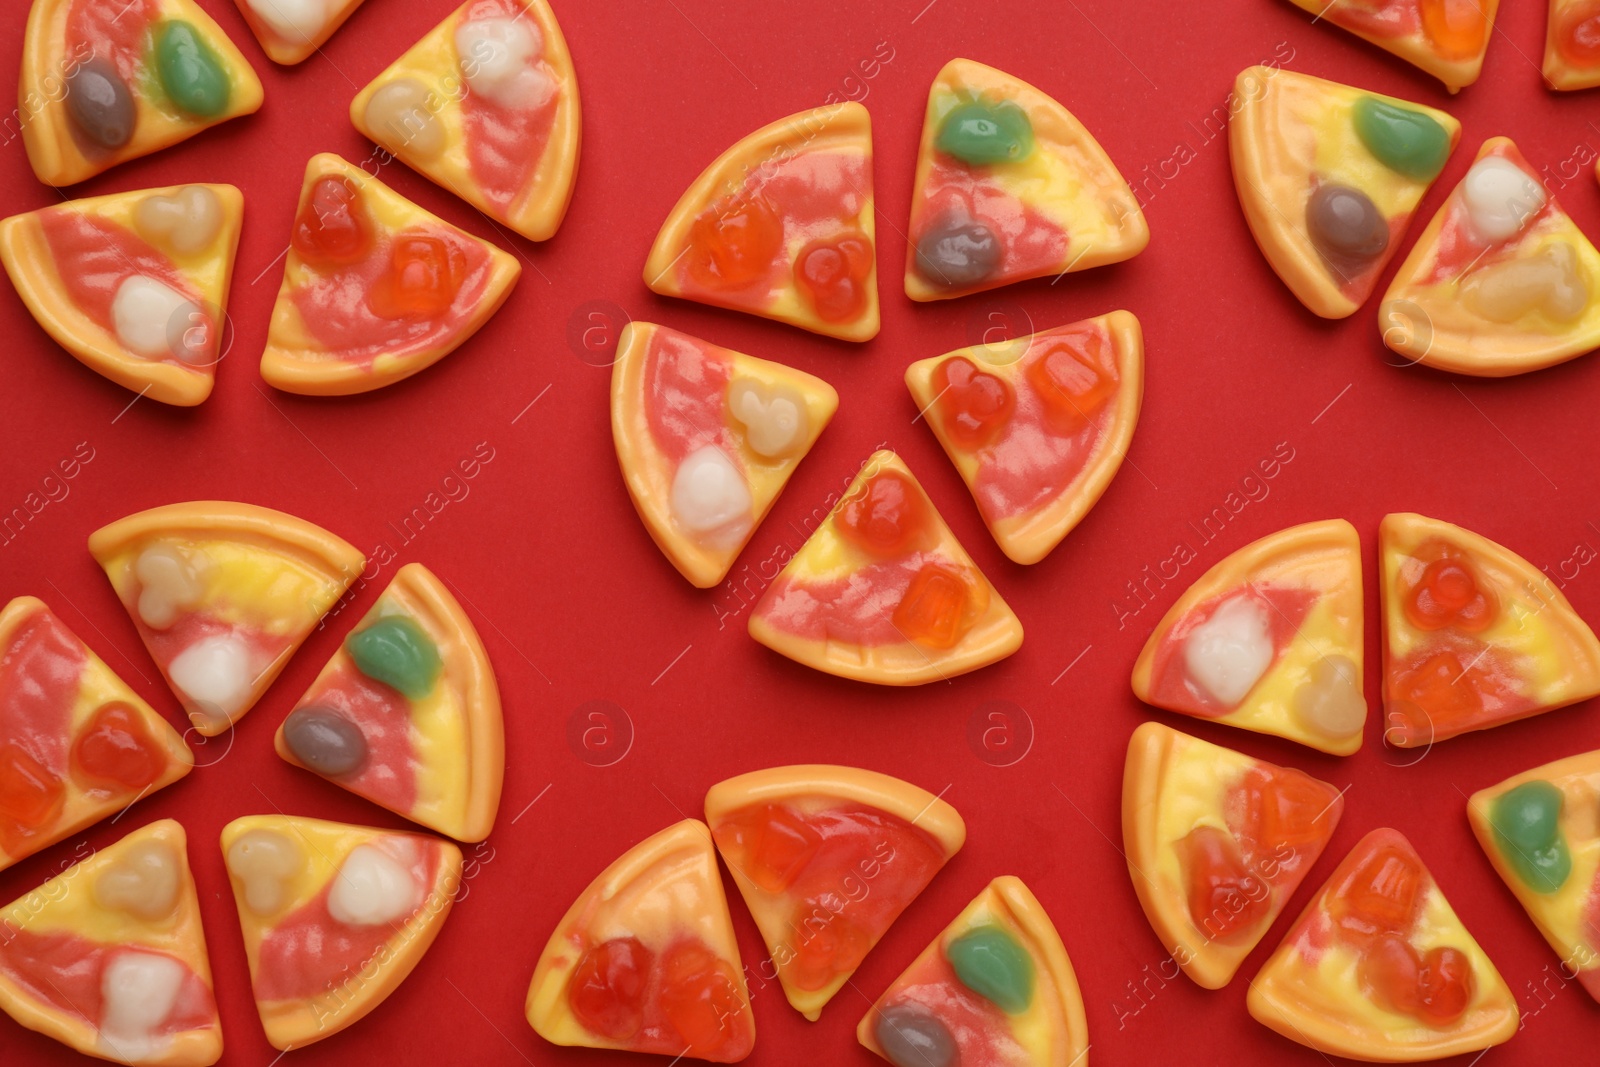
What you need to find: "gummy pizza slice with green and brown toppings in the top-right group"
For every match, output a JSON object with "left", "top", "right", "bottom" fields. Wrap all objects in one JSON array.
[{"left": 1229, "top": 67, "right": 1461, "bottom": 318}]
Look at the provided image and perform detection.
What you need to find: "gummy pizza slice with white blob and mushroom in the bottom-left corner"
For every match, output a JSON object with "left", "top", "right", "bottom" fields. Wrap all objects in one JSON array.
[{"left": 0, "top": 819, "right": 222, "bottom": 1067}]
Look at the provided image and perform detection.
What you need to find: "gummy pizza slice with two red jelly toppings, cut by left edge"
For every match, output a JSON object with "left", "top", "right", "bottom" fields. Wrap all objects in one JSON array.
[{"left": 0, "top": 597, "right": 194, "bottom": 870}]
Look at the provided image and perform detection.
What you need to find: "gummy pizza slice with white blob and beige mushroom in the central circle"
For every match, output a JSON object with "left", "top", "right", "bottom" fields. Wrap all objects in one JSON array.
[{"left": 611, "top": 322, "right": 838, "bottom": 589}]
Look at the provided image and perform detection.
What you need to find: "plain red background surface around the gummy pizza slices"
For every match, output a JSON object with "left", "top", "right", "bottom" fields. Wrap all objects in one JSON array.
[{"left": 0, "top": 0, "right": 1600, "bottom": 1065}]
